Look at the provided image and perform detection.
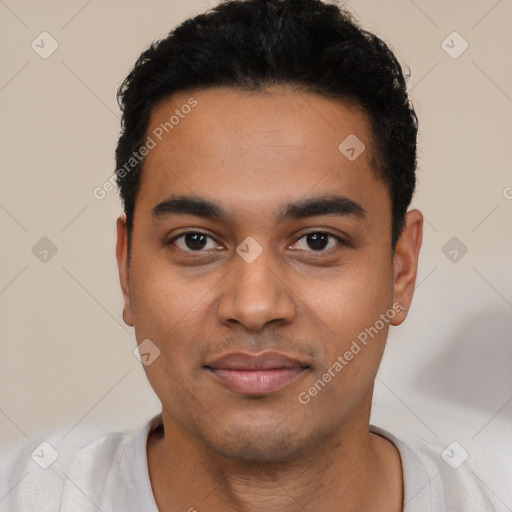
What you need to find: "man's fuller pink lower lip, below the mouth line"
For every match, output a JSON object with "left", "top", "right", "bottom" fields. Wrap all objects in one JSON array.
[{"left": 206, "top": 368, "right": 305, "bottom": 396}]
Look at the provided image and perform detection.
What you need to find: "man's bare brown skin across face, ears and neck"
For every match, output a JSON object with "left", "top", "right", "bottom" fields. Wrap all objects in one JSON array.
[{"left": 117, "top": 87, "right": 423, "bottom": 512}]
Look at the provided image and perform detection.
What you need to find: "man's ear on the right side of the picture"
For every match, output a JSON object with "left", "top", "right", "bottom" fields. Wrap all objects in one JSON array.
[{"left": 391, "top": 210, "right": 423, "bottom": 325}]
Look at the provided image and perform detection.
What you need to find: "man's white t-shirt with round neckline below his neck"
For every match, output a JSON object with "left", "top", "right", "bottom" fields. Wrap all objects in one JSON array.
[{"left": 0, "top": 414, "right": 495, "bottom": 512}]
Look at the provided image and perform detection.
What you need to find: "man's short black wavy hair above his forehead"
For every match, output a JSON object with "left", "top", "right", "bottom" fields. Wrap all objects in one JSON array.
[{"left": 116, "top": 0, "right": 418, "bottom": 253}]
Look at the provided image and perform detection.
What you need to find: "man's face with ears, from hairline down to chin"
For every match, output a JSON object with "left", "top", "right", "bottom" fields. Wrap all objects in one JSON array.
[{"left": 117, "top": 89, "right": 421, "bottom": 461}]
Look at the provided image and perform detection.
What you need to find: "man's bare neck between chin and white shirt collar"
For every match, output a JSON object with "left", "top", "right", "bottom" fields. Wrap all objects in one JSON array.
[{"left": 148, "top": 410, "right": 403, "bottom": 512}]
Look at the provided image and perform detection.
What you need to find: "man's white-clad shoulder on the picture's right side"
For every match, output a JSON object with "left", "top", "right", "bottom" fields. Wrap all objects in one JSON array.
[{"left": 371, "top": 426, "right": 496, "bottom": 512}]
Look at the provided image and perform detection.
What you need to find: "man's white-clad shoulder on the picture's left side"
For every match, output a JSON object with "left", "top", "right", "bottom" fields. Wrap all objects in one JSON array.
[{"left": 0, "top": 422, "right": 133, "bottom": 512}]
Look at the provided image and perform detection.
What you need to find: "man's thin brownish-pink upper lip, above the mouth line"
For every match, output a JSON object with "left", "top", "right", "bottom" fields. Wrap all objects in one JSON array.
[{"left": 206, "top": 352, "right": 308, "bottom": 370}]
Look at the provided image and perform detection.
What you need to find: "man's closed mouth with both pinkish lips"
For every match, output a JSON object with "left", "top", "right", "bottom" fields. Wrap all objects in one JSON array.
[{"left": 205, "top": 352, "right": 309, "bottom": 397}]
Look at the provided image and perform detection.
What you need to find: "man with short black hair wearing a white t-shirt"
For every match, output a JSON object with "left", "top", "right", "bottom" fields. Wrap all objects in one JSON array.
[{"left": 2, "top": 0, "right": 496, "bottom": 512}]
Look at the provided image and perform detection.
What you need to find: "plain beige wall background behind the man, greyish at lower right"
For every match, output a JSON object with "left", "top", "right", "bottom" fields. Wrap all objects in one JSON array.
[{"left": 0, "top": 0, "right": 512, "bottom": 504}]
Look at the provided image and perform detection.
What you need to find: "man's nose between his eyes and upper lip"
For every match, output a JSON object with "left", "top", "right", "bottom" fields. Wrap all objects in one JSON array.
[{"left": 217, "top": 244, "right": 296, "bottom": 331}]
